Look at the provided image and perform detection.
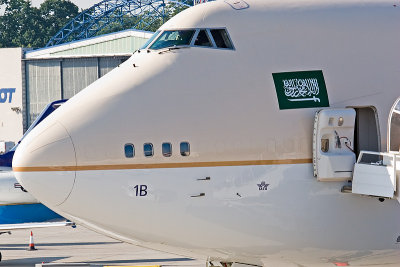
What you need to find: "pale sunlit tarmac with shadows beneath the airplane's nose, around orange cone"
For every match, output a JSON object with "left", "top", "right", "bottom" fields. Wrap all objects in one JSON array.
[{"left": 0, "top": 226, "right": 205, "bottom": 267}]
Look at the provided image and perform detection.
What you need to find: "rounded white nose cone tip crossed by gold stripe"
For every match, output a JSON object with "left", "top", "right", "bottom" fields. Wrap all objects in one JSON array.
[{"left": 13, "top": 121, "right": 76, "bottom": 206}]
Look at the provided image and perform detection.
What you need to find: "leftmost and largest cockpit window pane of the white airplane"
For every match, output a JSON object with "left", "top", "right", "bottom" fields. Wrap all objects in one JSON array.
[{"left": 150, "top": 30, "right": 195, "bottom": 49}]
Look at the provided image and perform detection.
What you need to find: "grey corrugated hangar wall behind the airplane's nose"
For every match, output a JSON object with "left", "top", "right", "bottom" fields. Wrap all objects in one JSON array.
[{"left": 24, "top": 56, "right": 129, "bottom": 131}]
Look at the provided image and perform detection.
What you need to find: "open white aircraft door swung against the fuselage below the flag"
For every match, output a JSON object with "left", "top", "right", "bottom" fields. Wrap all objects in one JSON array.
[{"left": 313, "top": 108, "right": 356, "bottom": 181}]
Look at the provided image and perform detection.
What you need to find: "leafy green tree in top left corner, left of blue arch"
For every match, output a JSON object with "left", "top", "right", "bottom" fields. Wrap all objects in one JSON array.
[{"left": 0, "top": 0, "right": 78, "bottom": 47}]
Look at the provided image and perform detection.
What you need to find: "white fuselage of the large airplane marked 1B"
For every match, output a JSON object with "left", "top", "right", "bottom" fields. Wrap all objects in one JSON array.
[{"left": 13, "top": 0, "right": 400, "bottom": 265}]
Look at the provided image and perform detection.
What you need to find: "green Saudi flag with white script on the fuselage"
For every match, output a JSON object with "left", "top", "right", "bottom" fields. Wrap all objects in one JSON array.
[{"left": 272, "top": 70, "right": 329, "bottom": 109}]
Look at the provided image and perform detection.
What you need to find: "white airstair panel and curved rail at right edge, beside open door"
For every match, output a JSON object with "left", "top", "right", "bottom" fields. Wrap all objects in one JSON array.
[{"left": 352, "top": 98, "right": 400, "bottom": 202}]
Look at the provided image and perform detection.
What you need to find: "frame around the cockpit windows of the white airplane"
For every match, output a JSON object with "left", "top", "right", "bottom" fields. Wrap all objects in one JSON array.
[{"left": 141, "top": 27, "right": 236, "bottom": 51}]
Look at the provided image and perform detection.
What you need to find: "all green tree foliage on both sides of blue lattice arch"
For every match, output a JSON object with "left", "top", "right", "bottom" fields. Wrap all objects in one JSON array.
[{"left": 0, "top": 0, "right": 192, "bottom": 47}]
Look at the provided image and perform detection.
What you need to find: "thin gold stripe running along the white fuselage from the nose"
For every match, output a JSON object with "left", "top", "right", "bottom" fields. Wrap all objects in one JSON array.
[{"left": 13, "top": 159, "right": 312, "bottom": 172}]
